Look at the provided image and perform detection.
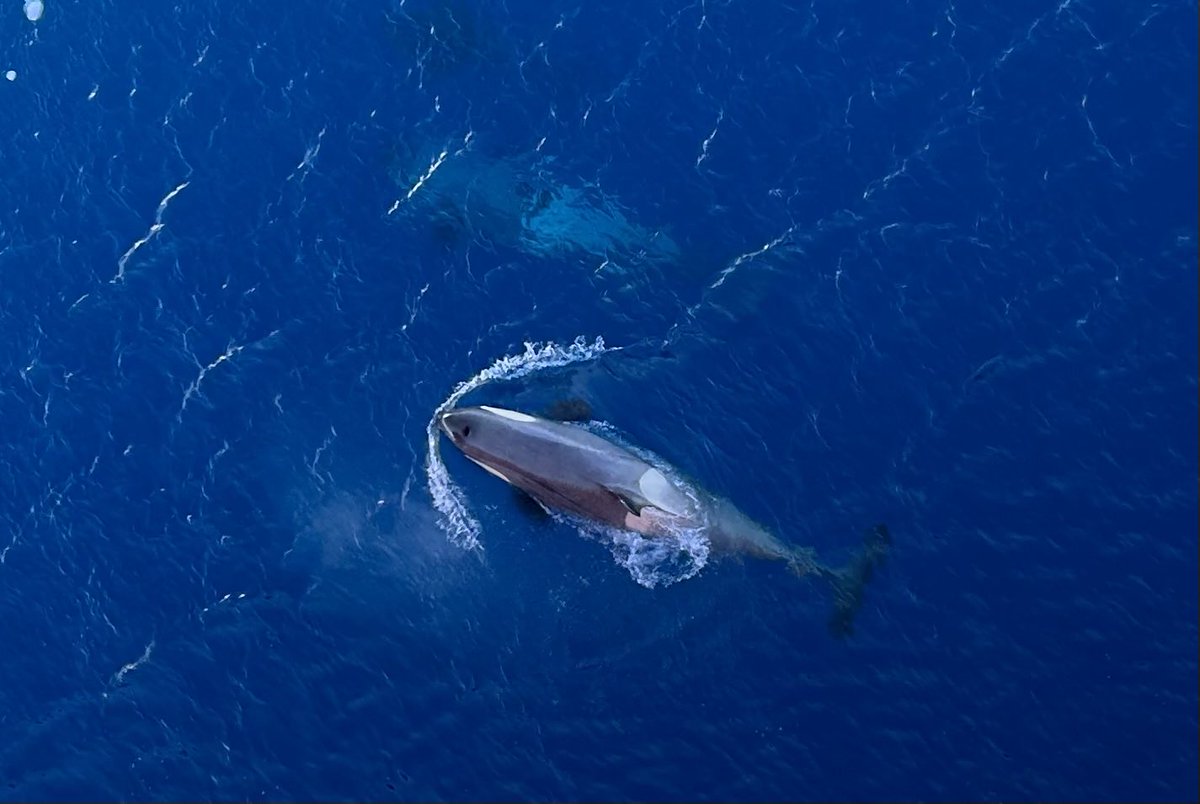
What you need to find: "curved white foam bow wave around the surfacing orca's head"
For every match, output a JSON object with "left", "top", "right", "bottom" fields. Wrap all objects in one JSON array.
[{"left": 425, "top": 336, "right": 620, "bottom": 550}]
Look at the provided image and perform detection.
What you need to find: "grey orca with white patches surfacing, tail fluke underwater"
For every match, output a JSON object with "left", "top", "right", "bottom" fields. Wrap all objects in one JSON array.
[{"left": 437, "top": 406, "right": 890, "bottom": 636}]
